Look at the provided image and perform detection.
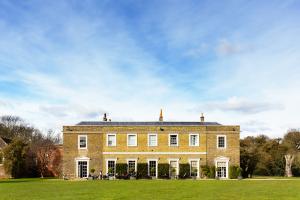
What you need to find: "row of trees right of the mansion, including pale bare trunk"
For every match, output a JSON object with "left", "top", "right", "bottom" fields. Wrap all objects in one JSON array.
[{"left": 240, "top": 130, "right": 300, "bottom": 178}]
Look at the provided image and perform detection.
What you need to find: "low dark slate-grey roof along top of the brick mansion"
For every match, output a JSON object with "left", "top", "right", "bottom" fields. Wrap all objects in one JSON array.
[{"left": 76, "top": 121, "right": 221, "bottom": 126}]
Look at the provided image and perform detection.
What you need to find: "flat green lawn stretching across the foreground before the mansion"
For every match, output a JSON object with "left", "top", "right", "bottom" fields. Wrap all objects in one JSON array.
[{"left": 0, "top": 179, "right": 300, "bottom": 200}]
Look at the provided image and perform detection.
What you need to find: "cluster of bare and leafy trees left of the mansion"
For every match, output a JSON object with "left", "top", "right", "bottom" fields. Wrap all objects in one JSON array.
[{"left": 0, "top": 116, "right": 62, "bottom": 178}]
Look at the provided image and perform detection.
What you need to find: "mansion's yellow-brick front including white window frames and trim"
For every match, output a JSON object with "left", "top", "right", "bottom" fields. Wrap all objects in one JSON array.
[{"left": 63, "top": 117, "right": 240, "bottom": 178}]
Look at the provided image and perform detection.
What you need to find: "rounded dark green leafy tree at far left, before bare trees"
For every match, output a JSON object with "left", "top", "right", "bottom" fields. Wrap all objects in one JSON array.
[{"left": 4, "top": 139, "right": 28, "bottom": 178}]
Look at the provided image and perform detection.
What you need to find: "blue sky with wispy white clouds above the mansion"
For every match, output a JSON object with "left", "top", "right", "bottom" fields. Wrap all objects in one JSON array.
[{"left": 0, "top": 0, "right": 300, "bottom": 137}]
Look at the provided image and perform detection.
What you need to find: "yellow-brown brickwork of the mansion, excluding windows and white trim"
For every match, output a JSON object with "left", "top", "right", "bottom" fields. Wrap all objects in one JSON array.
[{"left": 63, "top": 126, "right": 240, "bottom": 177}]
